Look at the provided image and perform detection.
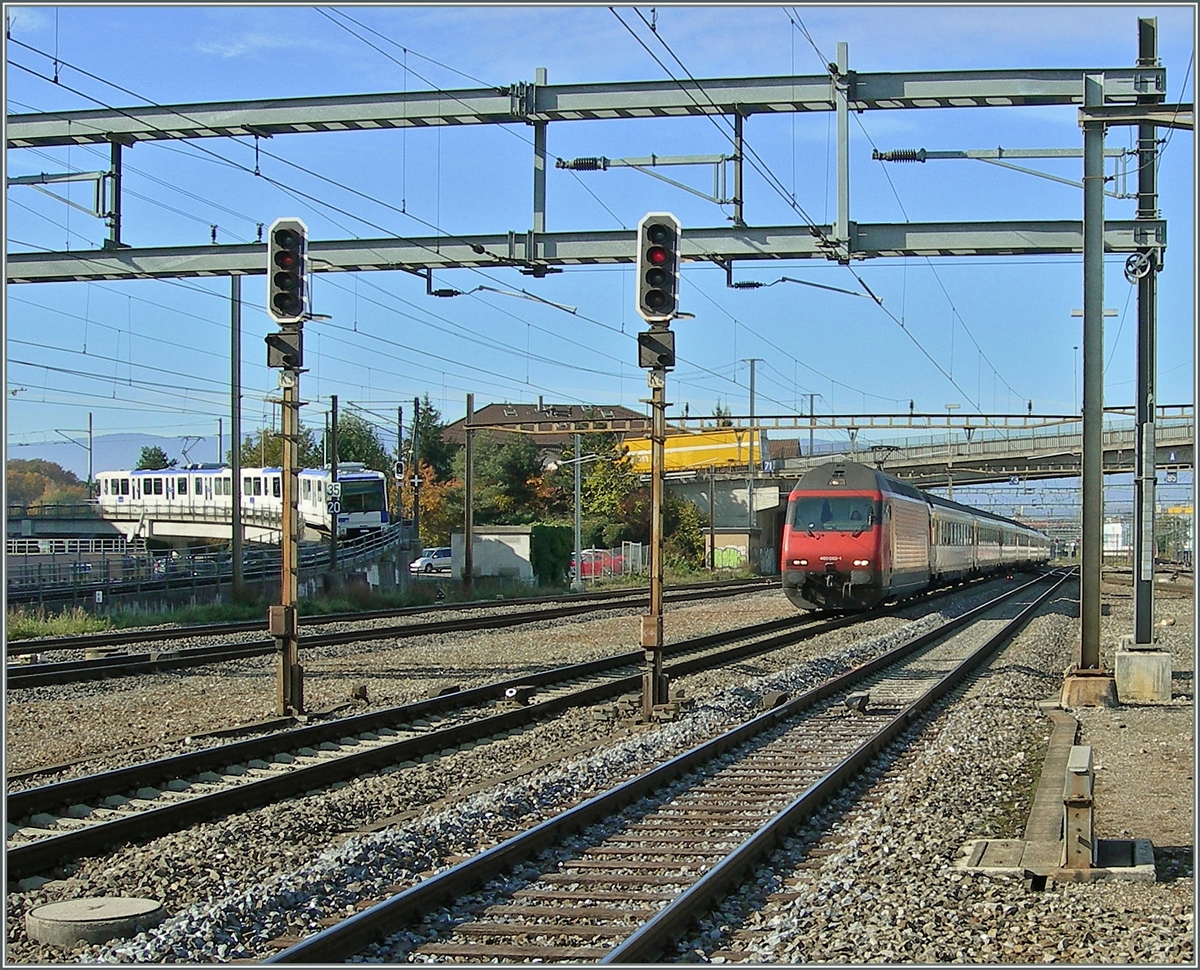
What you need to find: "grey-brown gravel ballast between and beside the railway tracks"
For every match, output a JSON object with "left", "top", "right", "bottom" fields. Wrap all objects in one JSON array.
[{"left": 7, "top": 576, "right": 1192, "bottom": 963}]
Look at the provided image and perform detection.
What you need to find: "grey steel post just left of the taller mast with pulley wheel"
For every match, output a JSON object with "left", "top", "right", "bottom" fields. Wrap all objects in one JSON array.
[{"left": 1079, "top": 74, "right": 1104, "bottom": 670}]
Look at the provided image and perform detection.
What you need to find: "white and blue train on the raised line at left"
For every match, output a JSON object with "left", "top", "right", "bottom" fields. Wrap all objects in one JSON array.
[{"left": 96, "top": 462, "right": 388, "bottom": 534}]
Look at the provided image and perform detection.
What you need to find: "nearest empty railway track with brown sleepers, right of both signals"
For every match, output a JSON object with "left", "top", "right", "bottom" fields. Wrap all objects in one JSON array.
[{"left": 258, "top": 574, "right": 1067, "bottom": 963}]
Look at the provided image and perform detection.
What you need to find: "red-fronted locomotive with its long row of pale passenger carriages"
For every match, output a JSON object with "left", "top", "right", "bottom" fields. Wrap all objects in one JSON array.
[{"left": 780, "top": 461, "right": 1050, "bottom": 610}]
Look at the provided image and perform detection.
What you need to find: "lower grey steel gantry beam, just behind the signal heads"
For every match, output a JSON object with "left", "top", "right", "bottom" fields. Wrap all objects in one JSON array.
[{"left": 0, "top": 220, "right": 1166, "bottom": 283}]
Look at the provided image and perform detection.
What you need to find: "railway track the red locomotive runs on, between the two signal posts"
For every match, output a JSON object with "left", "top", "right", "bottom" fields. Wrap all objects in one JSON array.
[{"left": 6, "top": 612, "right": 877, "bottom": 878}]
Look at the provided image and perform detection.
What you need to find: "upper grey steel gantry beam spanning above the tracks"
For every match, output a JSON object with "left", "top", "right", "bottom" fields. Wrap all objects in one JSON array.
[{"left": 6, "top": 67, "right": 1166, "bottom": 148}]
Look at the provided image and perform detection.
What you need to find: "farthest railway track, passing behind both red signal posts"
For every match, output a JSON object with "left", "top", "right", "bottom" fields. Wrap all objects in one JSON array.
[{"left": 7, "top": 580, "right": 779, "bottom": 689}]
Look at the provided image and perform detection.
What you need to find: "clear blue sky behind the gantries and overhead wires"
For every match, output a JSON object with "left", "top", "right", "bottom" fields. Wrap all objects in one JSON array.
[{"left": 4, "top": 5, "right": 1195, "bottom": 468}]
